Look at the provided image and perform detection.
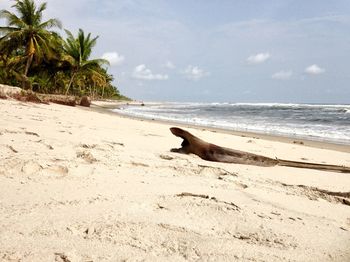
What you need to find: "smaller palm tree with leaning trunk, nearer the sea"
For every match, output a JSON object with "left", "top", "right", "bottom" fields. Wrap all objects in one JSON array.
[{"left": 63, "top": 29, "right": 109, "bottom": 95}]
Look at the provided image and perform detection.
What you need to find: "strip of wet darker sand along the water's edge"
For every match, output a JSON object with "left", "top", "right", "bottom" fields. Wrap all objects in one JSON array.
[{"left": 90, "top": 101, "right": 350, "bottom": 153}]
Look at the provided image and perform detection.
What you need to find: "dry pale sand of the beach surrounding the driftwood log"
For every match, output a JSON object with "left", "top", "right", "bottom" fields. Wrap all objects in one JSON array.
[{"left": 0, "top": 100, "right": 350, "bottom": 261}]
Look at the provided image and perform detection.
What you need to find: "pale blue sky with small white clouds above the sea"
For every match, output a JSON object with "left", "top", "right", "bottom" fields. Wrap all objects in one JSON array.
[{"left": 0, "top": 0, "right": 350, "bottom": 104}]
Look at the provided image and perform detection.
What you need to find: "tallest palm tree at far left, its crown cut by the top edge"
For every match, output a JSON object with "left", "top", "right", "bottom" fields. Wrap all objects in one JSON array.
[{"left": 0, "top": 0, "right": 62, "bottom": 87}]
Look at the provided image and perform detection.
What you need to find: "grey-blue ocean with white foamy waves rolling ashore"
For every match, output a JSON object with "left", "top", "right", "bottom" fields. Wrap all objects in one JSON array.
[{"left": 115, "top": 103, "right": 350, "bottom": 146}]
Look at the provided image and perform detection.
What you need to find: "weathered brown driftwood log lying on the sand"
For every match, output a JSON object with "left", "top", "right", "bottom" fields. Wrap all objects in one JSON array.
[{"left": 170, "top": 127, "right": 350, "bottom": 173}]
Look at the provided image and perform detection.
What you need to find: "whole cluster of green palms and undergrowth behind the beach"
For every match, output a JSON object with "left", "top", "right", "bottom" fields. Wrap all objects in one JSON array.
[{"left": 0, "top": 0, "right": 126, "bottom": 99}]
